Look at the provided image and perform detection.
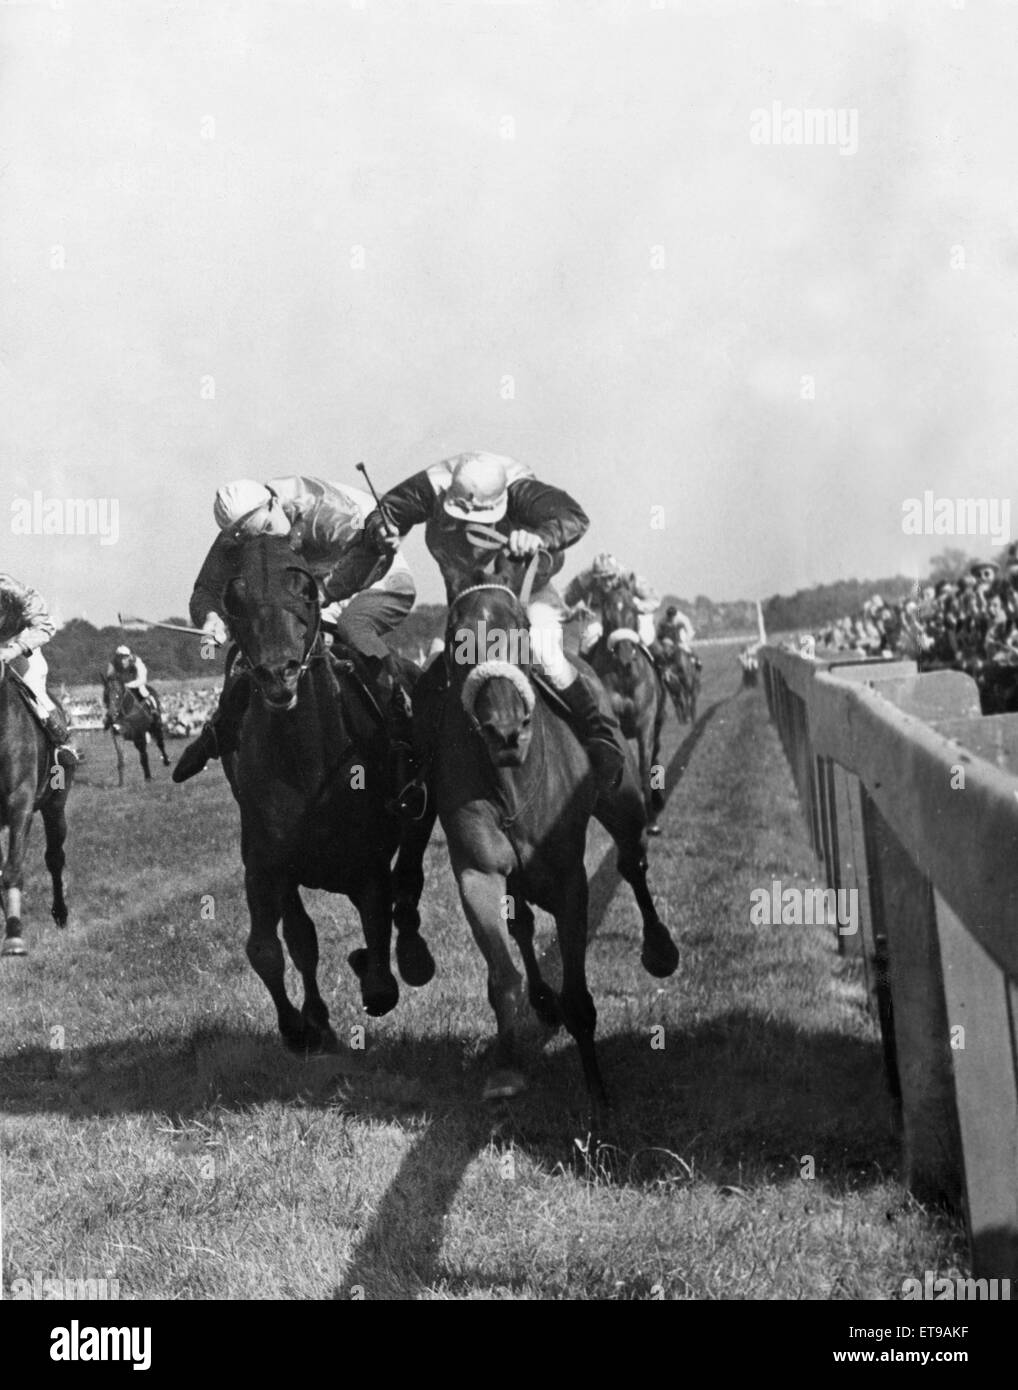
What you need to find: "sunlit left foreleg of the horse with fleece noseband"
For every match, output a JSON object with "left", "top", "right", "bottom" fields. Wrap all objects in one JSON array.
[{"left": 456, "top": 869, "right": 527, "bottom": 1101}]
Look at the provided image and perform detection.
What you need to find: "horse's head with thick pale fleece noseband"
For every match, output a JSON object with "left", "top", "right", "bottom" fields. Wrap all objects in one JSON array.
[{"left": 445, "top": 577, "right": 535, "bottom": 767}]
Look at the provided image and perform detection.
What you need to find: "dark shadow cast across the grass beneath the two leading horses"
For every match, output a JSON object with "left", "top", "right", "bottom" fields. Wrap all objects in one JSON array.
[{"left": 0, "top": 689, "right": 897, "bottom": 1298}]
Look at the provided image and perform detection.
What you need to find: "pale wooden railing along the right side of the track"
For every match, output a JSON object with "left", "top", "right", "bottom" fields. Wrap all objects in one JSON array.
[{"left": 759, "top": 646, "right": 1018, "bottom": 1280}]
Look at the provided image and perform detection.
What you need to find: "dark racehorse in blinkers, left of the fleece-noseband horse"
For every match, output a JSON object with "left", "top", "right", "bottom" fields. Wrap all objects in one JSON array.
[{"left": 212, "top": 535, "right": 435, "bottom": 1054}]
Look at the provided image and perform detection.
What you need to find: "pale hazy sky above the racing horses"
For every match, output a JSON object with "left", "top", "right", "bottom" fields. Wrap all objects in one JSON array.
[{"left": 0, "top": 0, "right": 1018, "bottom": 624}]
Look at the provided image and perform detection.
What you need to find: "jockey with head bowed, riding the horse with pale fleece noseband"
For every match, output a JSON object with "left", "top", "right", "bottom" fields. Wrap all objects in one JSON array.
[{"left": 364, "top": 452, "right": 623, "bottom": 787}]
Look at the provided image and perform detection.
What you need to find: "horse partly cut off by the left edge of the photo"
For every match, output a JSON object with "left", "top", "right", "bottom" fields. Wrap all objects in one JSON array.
[{"left": 0, "top": 662, "right": 74, "bottom": 956}]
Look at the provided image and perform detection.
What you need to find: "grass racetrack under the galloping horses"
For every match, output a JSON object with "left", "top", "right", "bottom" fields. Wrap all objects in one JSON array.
[{"left": 0, "top": 646, "right": 967, "bottom": 1298}]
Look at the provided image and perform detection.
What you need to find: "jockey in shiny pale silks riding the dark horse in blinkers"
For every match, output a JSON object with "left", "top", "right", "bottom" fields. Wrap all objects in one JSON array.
[{"left": 172, "top": 477, "right": 417, "bottom": 787}]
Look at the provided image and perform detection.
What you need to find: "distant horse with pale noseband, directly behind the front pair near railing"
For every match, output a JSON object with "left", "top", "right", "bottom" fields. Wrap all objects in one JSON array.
[{"left": 587, "top": 585, "right": 665, "bottom": 835}]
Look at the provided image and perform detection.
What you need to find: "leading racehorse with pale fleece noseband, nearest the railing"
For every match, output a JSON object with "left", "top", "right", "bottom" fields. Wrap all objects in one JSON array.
[{"left": 425, "top": 573, "right": 679, "bottom": 1123}]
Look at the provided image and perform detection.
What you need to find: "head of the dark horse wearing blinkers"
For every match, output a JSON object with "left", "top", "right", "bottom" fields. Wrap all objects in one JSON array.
[{"left": 223, "top": 535, "right": 320, "bottom": 710}]
